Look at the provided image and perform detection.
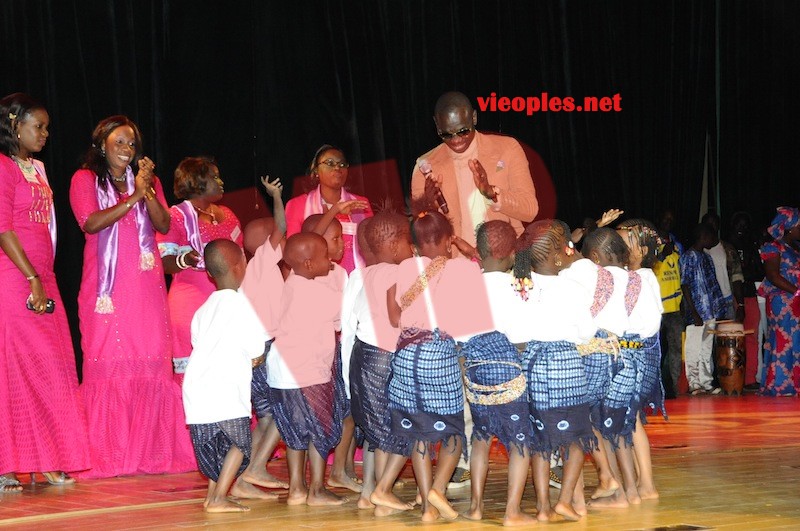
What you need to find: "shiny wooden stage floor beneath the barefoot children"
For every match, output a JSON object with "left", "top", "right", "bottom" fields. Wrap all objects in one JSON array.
[{"left": 0, "top": 395, "right": 800, "bottom": 531}]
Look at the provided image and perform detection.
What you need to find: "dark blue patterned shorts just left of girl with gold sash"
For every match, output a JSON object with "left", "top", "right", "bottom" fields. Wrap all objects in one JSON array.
[{"left": 350, "top": 338, "right": 392, "bottom": 451}]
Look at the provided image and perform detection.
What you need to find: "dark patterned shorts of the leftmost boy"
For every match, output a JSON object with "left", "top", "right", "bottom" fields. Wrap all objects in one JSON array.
[{"left": 189, "top": 417, "right": 252, "bottom": 481}]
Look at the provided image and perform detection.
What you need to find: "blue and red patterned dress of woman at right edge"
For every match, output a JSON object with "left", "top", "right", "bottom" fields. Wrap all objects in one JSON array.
[{"left": 759, "top": 241, "right": 800, "bottom": 396}]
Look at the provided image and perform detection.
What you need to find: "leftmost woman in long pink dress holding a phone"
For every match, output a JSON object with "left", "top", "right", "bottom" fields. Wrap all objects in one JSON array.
[{"left": 0, "top": 93, "right": 90, "bottom": 494}]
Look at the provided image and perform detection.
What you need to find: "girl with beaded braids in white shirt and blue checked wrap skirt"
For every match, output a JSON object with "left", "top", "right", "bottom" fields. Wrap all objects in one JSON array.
[{"left": 514, "top": 219, "right": 597, "bottom": 521}]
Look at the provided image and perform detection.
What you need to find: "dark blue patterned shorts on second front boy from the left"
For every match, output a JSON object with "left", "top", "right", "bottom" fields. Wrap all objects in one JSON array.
[{"left": 272, "top": 381, "right": 342, "bottom": 456}]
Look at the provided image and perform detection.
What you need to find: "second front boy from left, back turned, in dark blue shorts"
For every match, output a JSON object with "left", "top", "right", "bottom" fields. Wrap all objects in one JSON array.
[{"left": 267, "top": 233, "right": 347, "bottom": 506}]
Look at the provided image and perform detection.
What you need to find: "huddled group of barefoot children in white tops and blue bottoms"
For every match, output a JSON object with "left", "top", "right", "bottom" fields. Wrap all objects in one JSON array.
[{"left": 189, "top": 192, "right": 663, "bottom": 525}]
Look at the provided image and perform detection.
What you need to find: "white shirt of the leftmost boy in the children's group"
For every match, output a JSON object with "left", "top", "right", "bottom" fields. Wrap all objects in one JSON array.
[{"left": 183, "top": 289, "right": 268, "bottom": 424}]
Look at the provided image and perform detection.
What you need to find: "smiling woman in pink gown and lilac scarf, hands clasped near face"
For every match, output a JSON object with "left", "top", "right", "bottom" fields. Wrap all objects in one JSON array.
[{"left": 70, "top": 116, "right": 196, "bottom": 478}]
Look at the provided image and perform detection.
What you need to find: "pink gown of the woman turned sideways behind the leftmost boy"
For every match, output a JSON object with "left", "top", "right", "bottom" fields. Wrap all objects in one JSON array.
[{"left": 156, "top": 206, "right": 244, "bottom": 385}]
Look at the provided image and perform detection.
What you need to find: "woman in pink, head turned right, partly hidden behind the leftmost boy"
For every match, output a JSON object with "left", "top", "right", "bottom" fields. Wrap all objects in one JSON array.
[{"left": 156, "top": 157, "right": 243, "bottom": 385}]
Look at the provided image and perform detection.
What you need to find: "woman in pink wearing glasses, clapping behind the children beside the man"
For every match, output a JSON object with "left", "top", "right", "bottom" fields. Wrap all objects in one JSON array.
[{"left": 286, "top": 144, "right": 372, "bottom": 274}]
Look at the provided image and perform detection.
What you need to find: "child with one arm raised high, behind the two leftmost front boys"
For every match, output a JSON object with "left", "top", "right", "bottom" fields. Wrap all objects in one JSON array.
[{"left": 237, "top": 177, "right": 289, "bottom": 493}]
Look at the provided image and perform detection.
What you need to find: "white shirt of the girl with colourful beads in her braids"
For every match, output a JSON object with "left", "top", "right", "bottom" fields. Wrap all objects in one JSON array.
[{"left": 508, "top": 273, "right": 597, "bottom": 344}]
